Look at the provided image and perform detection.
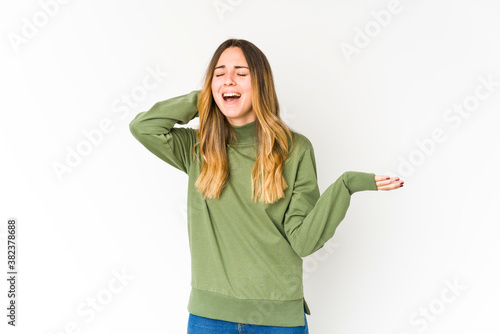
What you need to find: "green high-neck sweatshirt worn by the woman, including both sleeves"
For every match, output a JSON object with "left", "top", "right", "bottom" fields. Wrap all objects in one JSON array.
[{"left": 130, "top": 91, "right": 377, "bottom": 327}]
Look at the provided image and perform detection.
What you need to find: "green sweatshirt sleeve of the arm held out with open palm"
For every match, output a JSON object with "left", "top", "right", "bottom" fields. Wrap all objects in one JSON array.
[{"left": 284, "top": 147, "right": 377, "bottom": 257}]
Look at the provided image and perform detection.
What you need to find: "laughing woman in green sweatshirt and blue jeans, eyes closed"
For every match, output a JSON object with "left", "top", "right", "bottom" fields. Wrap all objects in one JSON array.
[{"left": 130, "top": 39, "right": 403, "bottom": 334}]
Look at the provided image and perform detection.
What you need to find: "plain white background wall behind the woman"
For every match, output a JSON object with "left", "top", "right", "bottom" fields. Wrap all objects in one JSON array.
[{"left": 0, "top": 0, "right": 500, "bottom": 334}]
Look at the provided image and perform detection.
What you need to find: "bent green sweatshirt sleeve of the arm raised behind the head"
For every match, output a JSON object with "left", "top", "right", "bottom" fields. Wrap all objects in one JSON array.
[{"left": 129, "top": 91, "right": 199, "bottom": 174}]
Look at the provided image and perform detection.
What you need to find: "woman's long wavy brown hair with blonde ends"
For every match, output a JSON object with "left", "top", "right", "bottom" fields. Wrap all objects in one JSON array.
[{"left": 191, "top": 39, "right": 293, "bottom": 204}]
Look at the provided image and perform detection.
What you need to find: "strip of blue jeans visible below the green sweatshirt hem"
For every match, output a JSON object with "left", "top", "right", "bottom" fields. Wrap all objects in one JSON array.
[{"left": 187, "top": 312, "right": 309, "bottom": 334}]
